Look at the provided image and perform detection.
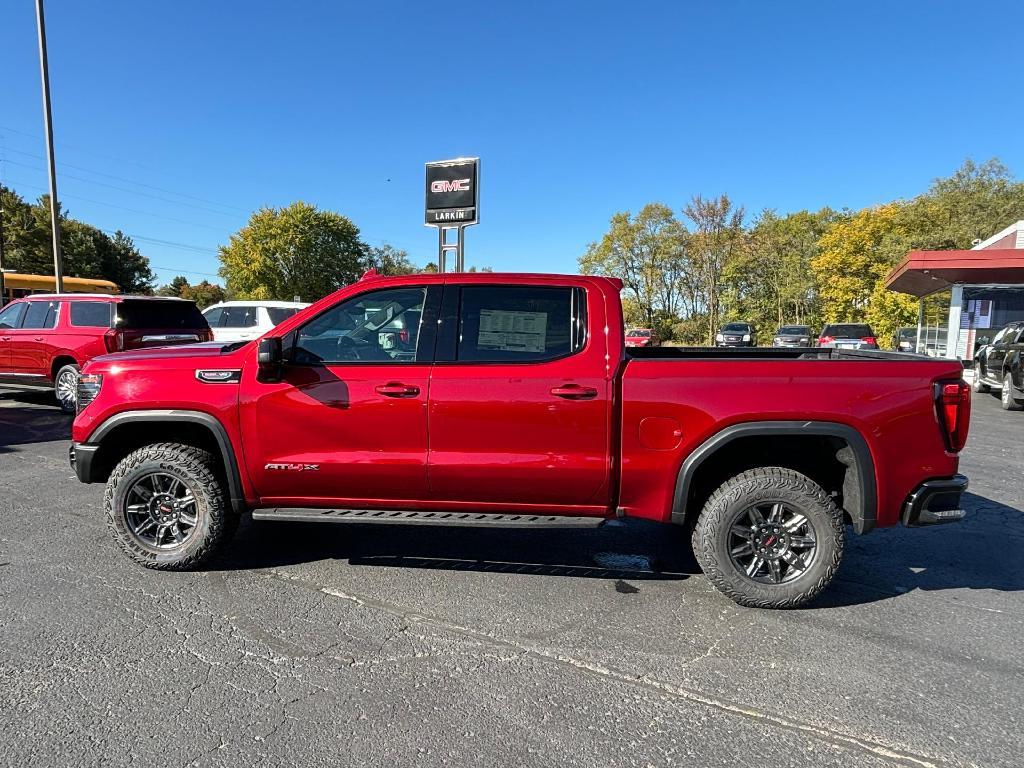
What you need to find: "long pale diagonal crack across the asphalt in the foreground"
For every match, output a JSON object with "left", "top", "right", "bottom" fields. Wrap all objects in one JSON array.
[{"left": 267, "top": 568, "right": 945, "bottom": 768}]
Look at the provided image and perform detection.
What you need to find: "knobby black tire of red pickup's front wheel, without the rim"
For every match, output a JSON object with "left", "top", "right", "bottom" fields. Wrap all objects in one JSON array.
[{"left": 103, "top": 442, "right": 239, "bottom": 570}]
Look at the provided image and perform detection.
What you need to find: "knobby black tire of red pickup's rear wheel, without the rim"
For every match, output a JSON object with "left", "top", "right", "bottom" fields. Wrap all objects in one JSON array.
[{"left": 692, "top": 467, "right": 846, "bottom": 608}]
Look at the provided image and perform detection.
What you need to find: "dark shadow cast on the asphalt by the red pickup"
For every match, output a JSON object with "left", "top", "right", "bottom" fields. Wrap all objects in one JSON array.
[{"left": 211, "top": 494, "right": 1024, "bottom": 609}]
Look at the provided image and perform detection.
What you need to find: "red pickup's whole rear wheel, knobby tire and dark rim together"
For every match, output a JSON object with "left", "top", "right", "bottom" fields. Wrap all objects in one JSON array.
[{"left": 693, "top": 467, "right": 846, "bottom": 608}]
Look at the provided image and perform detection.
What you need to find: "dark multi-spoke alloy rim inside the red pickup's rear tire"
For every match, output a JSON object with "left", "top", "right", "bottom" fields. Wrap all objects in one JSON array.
[{"left": 727, "top": 502, "right": 817, "bottom": 584}]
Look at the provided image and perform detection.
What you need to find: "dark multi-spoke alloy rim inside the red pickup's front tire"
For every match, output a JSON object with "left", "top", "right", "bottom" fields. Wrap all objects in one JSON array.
[{"left": 122, "top": 472, "right": 199, "bottom": 549}]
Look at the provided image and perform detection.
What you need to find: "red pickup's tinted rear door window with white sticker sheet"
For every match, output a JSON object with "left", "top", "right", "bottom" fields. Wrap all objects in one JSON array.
[{"left": 454, "top": 286, "right": 587, "bottom": 362}]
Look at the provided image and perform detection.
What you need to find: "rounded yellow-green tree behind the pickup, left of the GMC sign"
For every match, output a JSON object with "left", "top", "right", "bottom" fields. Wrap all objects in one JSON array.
[{"left": 220, "top": 202, "right": 368, "bottom": 301}]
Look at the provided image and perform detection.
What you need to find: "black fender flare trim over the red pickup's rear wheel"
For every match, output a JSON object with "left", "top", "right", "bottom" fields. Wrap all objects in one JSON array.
[{"left": 672, "top": 421, "right": 879, "bottom": 534}]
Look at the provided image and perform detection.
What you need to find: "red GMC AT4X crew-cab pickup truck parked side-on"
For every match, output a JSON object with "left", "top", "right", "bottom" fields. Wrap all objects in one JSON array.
[{"left": 71, "top": 273, "right": 971, "bottom": 607}]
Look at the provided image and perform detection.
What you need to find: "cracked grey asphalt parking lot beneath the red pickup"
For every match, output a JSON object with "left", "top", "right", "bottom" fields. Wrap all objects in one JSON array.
[{"left": 0, "top": 391, "right": 1024, "bottom": 768}]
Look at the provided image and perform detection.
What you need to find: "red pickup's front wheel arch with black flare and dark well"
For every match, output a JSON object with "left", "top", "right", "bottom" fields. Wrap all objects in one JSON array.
[{"left": 78, "top": 410, "right": 246, "bottom": 512}]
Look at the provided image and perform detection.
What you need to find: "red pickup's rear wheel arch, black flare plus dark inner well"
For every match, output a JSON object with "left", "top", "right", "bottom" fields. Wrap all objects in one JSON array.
[{"left": 672, "top": 421, "right": 878, "bottom": 534}]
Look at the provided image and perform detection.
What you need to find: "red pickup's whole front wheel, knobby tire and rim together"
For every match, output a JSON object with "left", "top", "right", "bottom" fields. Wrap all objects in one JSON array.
[{"left": 103, "top": 442, "right": 238, "bottom": 570}]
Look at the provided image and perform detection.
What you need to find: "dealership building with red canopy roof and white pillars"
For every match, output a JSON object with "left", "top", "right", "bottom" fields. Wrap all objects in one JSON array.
[{"left": 886, "top": 220, "right": 1024, "bottom": 360}]
